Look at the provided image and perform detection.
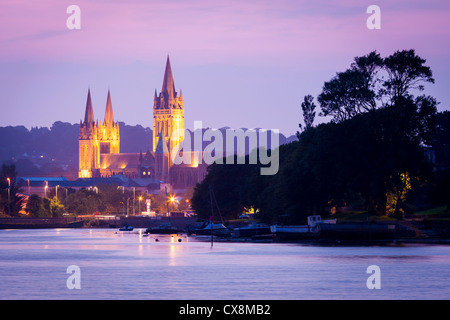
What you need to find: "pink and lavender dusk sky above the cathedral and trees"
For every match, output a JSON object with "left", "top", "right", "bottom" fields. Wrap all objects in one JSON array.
[{"left": 0, "top": 0, "right": 450, "bottom": 134}]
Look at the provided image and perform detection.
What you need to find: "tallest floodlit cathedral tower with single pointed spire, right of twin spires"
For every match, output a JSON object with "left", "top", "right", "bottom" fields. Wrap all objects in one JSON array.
[{"left": 153, "top": 56, "right": 184, "bottom": 158}]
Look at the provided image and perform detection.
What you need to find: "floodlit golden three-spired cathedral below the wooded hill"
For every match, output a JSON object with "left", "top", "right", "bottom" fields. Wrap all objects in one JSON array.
[{"left": 78, "top": 57, "right": 206, "bottom": 188}]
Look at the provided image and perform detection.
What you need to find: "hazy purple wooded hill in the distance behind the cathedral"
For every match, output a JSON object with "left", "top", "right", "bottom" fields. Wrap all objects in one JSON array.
[{"left": 0, "top": 121, "right": 297, "bottom": 176}]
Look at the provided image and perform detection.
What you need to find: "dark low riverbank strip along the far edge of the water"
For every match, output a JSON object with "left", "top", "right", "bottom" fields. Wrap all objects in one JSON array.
[{"left": 0, "top": 216, "right": 450, "bottom": 246}]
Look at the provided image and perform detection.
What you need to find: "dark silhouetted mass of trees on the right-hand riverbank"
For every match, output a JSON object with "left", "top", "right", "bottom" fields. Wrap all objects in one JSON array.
[{"left": 192, "top": 50, "right": 450, "bottom": 223}]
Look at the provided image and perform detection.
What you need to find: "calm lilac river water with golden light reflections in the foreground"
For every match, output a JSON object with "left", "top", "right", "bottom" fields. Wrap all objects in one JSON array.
[{"left": 0, "top": 229, "right": 450, "bottom": 300}]
